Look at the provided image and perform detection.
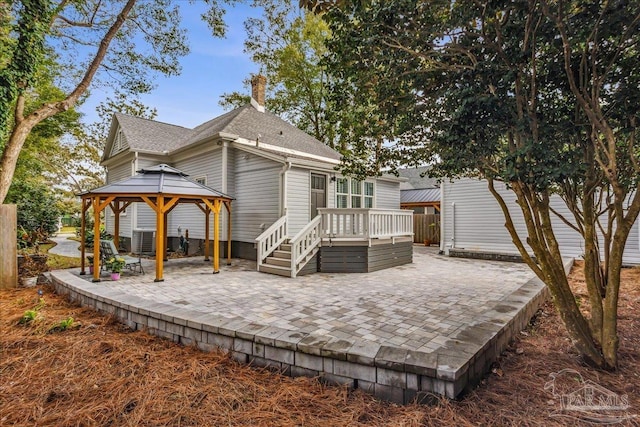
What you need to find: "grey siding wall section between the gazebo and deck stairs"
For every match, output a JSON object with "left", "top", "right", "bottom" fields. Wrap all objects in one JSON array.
[{"left": 231, "top": 152, "right": 282, "bottom": 243}]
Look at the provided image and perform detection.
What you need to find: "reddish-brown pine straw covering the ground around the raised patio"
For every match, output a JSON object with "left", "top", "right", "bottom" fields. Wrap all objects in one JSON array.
[{"left": 0, "top": 268, "right": 640, "bottom": 426}]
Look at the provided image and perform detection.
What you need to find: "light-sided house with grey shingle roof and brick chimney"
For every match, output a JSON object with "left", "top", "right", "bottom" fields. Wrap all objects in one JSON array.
[{"left": 101, "top": 76, "right": 410, "bottom": 275}]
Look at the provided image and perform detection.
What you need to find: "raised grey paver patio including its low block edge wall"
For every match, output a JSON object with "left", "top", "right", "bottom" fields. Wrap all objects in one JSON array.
[{"left": 52, "top": 245, "right": 560, "bottom": 403}]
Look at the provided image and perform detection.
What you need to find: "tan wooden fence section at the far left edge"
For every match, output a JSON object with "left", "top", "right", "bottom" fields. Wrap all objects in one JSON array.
[{"left": 0, "top": 205, "right": 18, "bottom": 289}]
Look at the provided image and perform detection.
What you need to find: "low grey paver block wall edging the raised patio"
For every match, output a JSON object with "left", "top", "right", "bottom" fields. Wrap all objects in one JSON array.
[{"left": 51, "top": 271, "right": 549, "bottom": 403}]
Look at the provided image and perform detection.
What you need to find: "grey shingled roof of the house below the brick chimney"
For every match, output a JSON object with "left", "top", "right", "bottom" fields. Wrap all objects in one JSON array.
[{"left": 103, "top": 104, "right": 341, "bottom": 161}]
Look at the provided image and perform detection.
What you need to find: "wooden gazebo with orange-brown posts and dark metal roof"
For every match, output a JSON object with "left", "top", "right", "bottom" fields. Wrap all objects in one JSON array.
[{"left": 80, "top": 164, "right": 233, "bottom": 282}]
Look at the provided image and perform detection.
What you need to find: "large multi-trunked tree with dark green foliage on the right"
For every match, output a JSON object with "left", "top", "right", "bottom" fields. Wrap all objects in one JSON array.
[{"left": 301, "top": 0, "right": 640, "bottom": 369}]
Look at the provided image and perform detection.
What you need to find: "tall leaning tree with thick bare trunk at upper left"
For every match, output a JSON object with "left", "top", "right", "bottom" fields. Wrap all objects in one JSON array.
[{"left": 0, "top": 0, "right": 238, "bottom": 203}]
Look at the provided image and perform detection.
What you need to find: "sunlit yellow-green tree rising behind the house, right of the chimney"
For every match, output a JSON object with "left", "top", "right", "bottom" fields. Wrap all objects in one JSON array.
[{"left": 220, "top": 0, "right": 338, "bottom": 148}]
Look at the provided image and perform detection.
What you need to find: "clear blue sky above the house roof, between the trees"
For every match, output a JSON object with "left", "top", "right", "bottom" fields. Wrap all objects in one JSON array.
[{"left": 80, "top": 2, "right": 261, "bottom": 127}]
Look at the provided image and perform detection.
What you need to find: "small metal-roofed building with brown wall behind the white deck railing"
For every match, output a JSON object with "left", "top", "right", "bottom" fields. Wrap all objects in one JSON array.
[{"left": 398, "top": 166, "right": 440, "bottom": 214}]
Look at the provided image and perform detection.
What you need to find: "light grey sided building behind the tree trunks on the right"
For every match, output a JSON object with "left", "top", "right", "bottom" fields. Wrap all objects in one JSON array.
[{"left": 440, "top": 178, "right": 640, "bottom": 264}]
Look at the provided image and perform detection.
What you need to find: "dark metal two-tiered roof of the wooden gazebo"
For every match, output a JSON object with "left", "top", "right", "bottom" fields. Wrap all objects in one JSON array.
[{"left": 81, "top": 164, "right": 233, "bottom": 200}]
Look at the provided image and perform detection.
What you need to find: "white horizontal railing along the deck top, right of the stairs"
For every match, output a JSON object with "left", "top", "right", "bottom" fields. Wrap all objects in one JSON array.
[{"left": 318, "top": 208, "right": 413, "bottom": 239}]
